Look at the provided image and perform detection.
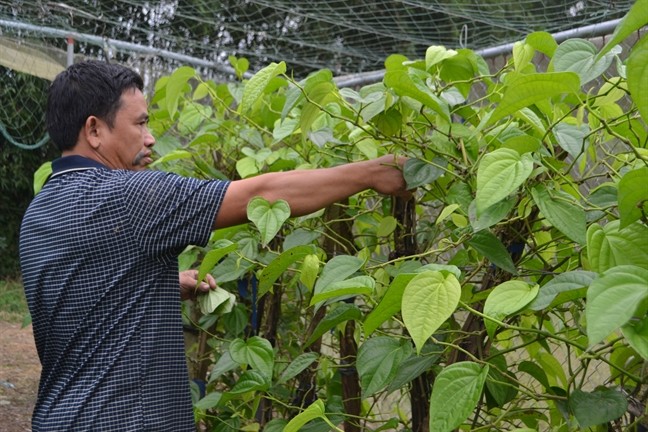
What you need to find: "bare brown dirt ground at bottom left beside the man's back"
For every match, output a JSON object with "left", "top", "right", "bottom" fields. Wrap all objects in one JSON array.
[{"left": 0, "top": 321, "right": 40, "bottom": 432}]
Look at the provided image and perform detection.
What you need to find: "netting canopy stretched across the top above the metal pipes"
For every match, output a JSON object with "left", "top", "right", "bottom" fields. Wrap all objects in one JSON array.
[{"left": 0, "top": 0, "right": 634, "bottom": 77}]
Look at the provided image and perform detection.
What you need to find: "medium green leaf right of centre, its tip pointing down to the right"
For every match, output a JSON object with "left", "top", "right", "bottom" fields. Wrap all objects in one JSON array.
[{"left": 531, "top": 184, "right": 587, "bottom": 245}]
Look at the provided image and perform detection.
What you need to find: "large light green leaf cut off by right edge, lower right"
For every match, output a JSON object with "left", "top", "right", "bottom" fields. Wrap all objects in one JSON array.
[{"left": 585, "top": 265, "right": 648, "bottom": 346}]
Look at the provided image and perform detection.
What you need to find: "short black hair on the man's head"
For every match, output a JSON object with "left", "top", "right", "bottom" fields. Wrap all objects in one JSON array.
[{"left": 46, "top": 61, "right": 144, "bottom": 151}]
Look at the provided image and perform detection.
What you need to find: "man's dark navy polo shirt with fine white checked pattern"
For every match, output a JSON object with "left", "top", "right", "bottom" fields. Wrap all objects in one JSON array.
[{"left": 20, "top": 156, "right": 229, "bottom": 432}]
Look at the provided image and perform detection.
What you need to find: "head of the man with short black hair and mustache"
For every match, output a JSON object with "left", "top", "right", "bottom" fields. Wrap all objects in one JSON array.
[{"left": 47, "top": 61, "right": 155, "bottom": 169}]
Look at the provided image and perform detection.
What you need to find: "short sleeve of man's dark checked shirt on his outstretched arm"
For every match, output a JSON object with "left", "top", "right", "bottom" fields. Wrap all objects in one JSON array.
[{"left": 124, "top": 171, "right": 229, "bottom": 258}]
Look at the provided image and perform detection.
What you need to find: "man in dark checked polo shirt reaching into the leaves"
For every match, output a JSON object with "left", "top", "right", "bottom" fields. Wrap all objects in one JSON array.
[{"left": 20, "top": 62, "right": 406, "bottom": 432}]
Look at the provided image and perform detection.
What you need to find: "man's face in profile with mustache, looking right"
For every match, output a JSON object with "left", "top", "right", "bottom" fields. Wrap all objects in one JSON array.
[{"left": 98, "top": 89, "right": 155, "bottom": 171}]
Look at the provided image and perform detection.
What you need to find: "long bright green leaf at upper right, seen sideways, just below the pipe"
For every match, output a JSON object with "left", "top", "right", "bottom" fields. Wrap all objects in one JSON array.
[{"left": 488, "top": 72, "right": 580, "bottom": 124}]
